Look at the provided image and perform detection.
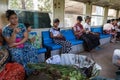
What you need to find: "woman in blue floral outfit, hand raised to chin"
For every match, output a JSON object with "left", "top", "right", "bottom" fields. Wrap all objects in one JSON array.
[{"left": 2, "top": 10, "right": 38, "bottom": 74}]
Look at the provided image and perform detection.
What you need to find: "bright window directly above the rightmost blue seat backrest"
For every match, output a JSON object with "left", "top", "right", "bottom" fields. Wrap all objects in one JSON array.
[{"left": 91, "top": 5, "right": 104, "bottom": 26}]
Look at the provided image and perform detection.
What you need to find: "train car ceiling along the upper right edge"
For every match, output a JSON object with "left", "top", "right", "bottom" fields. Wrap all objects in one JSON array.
[{"left": 71, "top": 0, "right": 120, "bottom": 9}]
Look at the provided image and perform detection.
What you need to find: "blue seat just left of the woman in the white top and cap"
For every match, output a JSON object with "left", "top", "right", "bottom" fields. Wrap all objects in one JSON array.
[{"left": 42, "top": 31, "right": 53, "bottom": 45}]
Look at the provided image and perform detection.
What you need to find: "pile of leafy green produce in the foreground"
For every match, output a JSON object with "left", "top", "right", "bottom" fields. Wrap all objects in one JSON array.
[{"left": 28, "top": 63, "right": 86, "bottom": 80}]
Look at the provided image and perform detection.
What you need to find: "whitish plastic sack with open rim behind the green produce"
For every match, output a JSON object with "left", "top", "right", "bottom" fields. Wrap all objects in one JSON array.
[{"left": 46, "top": 54, "right": 101, "bottom": 78}]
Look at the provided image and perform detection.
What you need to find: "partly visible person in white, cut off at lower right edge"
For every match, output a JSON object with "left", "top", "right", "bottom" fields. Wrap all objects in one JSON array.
[{"left": 112, "top": 49, "right": 120, "bottom": 68}]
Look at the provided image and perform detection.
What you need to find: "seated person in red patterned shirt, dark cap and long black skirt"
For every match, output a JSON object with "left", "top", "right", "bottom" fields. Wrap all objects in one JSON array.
[{"left": 73, "top": 16, "right": 100, "bottom": 51}]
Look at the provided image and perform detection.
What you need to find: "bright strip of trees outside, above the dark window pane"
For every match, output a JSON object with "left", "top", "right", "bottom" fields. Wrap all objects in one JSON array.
[{"left": 9, "top": 0, "right": 52, "bottom": 12}]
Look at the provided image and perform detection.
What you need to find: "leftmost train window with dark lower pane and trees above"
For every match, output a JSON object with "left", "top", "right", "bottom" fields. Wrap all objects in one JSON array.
[{"left": 8, "top": 0, "right": 53, "bottom": 28}]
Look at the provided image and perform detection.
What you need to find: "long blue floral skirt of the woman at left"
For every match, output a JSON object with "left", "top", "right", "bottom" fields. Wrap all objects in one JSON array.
[{"left": 8, "top": 42, "right": 38, "bottom": 75}]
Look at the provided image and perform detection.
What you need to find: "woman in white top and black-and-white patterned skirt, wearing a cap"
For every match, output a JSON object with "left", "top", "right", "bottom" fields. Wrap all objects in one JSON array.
[{"left": 50, "top": 19, "right": 71, "bottom": 54}]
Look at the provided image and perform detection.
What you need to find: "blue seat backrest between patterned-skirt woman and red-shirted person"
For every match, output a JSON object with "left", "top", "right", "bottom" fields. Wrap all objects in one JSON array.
[{"left": 61, "top": 29, "right": 76, "bottom": 40}]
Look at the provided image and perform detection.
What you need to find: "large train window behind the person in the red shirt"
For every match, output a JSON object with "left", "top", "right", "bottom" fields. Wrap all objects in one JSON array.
[{"left": 64, "top": 0, "right": 86, "bottom": 27}]
